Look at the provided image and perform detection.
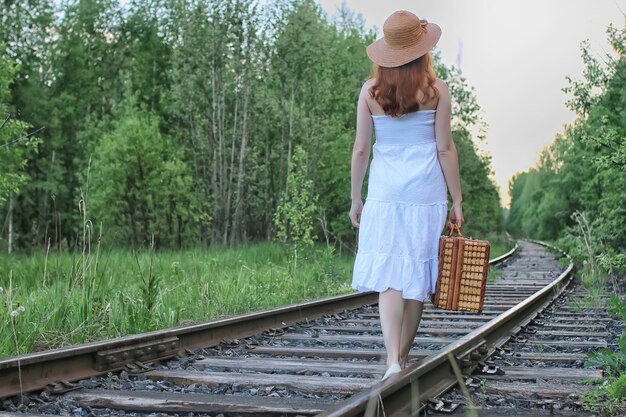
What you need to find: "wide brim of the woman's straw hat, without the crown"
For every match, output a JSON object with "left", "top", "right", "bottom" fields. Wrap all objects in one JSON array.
[{"left": 366, "top": 23, "right": 441, "bottom": 67}]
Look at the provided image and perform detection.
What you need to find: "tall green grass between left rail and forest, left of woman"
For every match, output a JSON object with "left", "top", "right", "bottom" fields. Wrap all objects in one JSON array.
[{"left": 0, "top": 243, "right": 353, "bottom": 357}]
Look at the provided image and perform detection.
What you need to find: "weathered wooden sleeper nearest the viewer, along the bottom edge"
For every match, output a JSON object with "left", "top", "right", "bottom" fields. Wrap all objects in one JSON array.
[{"left": 63, "top": 390, "right": 332, "bottom": 416}]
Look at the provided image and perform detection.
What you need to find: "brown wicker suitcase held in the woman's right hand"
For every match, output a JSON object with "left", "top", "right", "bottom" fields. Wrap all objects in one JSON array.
[{"left": 433, "top": 225, "right": 490, "bottom": 313}]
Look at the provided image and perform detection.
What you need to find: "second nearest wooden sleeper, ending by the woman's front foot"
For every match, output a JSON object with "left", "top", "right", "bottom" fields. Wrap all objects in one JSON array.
[{"left": 144, "top": 370, "right": 370, "bottom": 394}]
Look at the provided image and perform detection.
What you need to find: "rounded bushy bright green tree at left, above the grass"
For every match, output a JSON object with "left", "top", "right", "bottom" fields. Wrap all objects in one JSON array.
[{"left": 86, "top": 106, "right": 195, "bottom": 247}]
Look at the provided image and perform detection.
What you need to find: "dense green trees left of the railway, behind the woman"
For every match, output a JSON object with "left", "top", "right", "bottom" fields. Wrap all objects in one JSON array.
[{"left": 0, "top": 0, "right": 504, "bottom": 253}]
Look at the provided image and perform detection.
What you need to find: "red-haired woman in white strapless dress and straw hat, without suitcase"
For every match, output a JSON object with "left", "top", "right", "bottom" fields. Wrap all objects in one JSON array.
[{"left": 350, "top": 11, "right": 464, "bottom": 379}]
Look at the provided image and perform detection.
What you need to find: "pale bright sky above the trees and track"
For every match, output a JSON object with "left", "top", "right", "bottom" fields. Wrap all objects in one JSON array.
[{"left": 318, "top": 0, "right": 626, "bottom": 206}]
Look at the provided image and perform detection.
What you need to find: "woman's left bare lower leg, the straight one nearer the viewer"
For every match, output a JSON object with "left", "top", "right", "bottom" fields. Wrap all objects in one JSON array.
[{"left": 378, "top": 289, "right": 404, "bottom": 367}]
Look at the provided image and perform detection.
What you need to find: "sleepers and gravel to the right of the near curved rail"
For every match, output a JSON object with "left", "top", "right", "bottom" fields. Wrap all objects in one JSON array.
[{"left": 430, "top": 276, "right": 622, "bottom": 417}]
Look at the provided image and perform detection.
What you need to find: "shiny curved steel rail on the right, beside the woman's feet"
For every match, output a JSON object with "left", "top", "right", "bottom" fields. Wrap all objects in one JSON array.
[{"left": 318, "top": 241, "right": 574, "bottom": 417}]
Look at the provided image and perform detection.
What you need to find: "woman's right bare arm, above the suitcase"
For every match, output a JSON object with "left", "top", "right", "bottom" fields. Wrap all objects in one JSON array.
[{"left": 435, "top": 80, "right": 464, "bottom": 226}]
